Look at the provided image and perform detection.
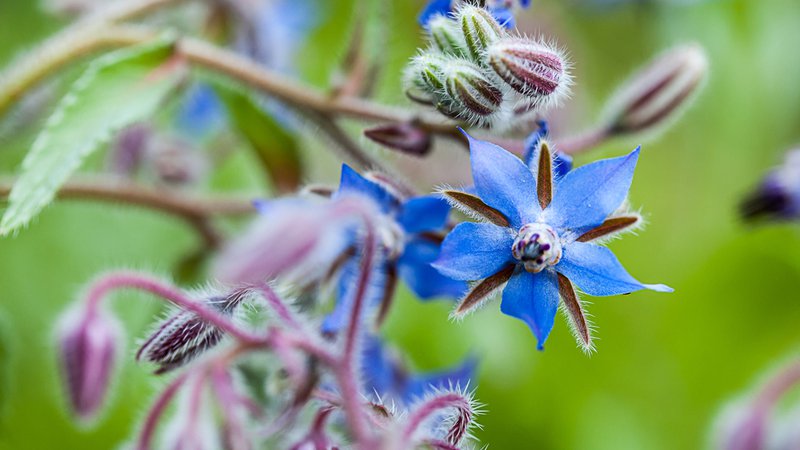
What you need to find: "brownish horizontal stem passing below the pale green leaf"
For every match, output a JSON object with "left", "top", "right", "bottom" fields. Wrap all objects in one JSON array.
[{"left": 0, "top": 178, "right": 255, "bottom": 248}]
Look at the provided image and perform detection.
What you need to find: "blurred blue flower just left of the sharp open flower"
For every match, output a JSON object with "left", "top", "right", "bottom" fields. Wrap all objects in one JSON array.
[{"left": 323, "top": 164, "right": 467, "bottom": 332}]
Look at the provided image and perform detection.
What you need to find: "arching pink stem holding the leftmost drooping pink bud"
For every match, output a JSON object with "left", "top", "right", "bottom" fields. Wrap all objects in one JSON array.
[{"left": 86, "top": 271, "right": 265, "bottom": 345}]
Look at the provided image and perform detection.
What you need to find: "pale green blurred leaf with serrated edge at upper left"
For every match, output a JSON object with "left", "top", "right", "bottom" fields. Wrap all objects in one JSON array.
[{"left": 0, "top": 38, "right": 183, "bottom": 235}]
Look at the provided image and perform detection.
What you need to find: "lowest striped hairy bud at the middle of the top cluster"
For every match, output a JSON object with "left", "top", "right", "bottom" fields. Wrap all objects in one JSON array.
[{"left": 437, "top": 60, "right": 503, "bottom": 124}]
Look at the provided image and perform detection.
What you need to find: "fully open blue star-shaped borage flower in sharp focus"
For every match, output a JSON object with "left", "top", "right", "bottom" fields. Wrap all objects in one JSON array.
[{"left": 433, "top": 133, "right": 672, "bottom": 350}]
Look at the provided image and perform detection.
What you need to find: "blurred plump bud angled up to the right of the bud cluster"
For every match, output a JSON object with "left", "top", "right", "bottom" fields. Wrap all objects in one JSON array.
[{"left": 606, "top": 44, "right": 708, "bottom": 134}]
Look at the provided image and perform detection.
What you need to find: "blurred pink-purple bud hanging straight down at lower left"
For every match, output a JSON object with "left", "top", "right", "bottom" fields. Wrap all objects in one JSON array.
[{"left": 58, "top": 305, "right": 120, "bottom": 420}]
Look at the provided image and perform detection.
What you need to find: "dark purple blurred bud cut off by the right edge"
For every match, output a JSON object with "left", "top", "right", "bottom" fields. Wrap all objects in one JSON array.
[{"left": 740, "top": 149, "right": 800, "bottom": 220}]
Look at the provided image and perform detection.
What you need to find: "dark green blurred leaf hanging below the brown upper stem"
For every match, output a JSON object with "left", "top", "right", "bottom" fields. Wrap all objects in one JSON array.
[{"left": 212, "top": 80, "right": 303, "bottom": 193}]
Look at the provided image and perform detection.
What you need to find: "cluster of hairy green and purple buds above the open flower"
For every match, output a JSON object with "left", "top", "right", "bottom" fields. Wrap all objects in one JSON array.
[{"left": 405, "top": 5, "right": 570, "bottom": 128}]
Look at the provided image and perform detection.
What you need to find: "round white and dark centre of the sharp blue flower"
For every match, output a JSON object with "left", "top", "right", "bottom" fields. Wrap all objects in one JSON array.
[{"left": 511, "top": 223, "right": 561, "bottom": 273}]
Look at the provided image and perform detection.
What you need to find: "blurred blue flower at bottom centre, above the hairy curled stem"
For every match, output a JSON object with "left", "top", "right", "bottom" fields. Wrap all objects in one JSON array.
[{"left": 362, "top": 336, "right": 478, "bottom": 406}]
